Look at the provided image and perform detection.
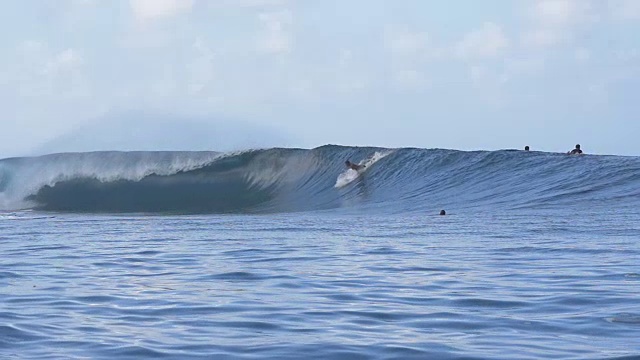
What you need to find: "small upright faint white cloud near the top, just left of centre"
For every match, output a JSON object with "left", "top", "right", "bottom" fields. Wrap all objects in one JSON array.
[{"left": 258, "top": 10, "right": 293, "bottom": 54}]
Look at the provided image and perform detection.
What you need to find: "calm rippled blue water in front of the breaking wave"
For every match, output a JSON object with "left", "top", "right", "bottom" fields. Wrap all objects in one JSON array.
[{"left": 0, "top": 214, "right": 640, "bottom": 359}]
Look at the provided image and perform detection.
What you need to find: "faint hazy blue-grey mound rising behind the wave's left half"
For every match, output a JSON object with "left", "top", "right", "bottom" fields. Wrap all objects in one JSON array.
[{"left": 32, "top": 113, "right": 291, "bottom": 154}]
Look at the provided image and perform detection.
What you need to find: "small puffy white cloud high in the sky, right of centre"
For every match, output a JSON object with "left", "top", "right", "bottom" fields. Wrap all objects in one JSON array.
[{"left": 454, "top": 22, "right": 509, "bottom": 59}]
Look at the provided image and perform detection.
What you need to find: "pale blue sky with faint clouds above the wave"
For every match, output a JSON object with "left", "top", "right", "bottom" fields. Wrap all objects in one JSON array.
[{"left": 0, "top": 0, "right": 640, "bottom": 158}]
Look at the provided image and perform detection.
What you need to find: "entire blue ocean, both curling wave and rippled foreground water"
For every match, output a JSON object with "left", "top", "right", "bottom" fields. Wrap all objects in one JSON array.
[{"left": 0, "top": 145, "right": 640, "bottom": 359}]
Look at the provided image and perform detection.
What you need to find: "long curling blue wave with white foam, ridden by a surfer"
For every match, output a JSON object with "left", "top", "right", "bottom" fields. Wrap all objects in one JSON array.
[{"left": 0, "top": 145, "right": 640, "bottom": 213}]
